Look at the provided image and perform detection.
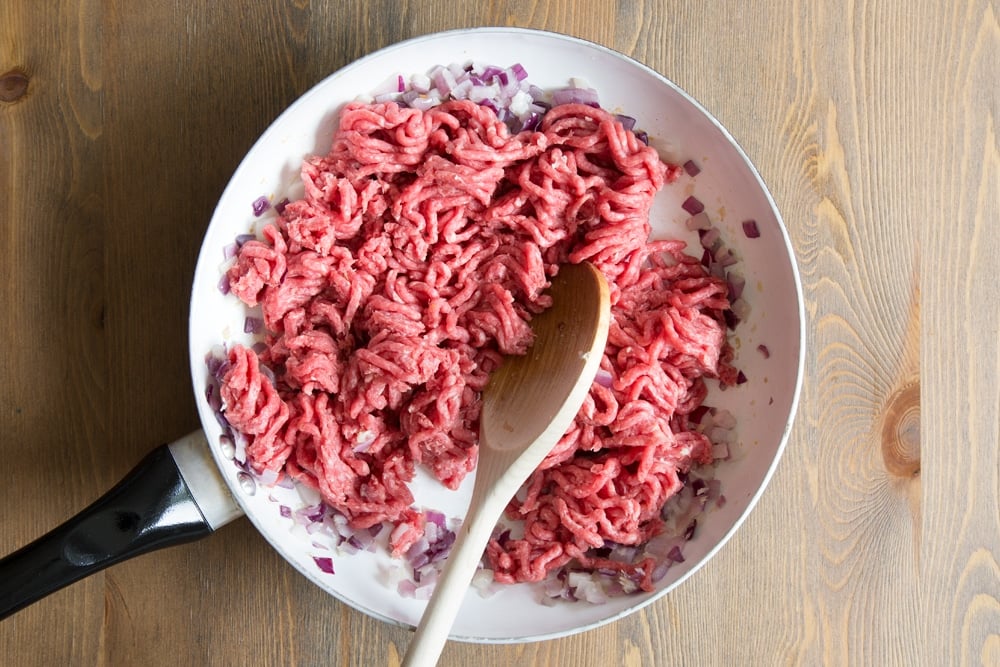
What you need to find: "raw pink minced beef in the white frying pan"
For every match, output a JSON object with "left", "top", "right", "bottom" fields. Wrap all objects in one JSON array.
[{"left": 222, "top": 101, "right": 735, "bottom": 584}]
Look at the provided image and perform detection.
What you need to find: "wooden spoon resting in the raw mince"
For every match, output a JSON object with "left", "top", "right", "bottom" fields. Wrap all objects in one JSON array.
[{"left": 403, "top": 263, "right": 611, "bottom": 667}]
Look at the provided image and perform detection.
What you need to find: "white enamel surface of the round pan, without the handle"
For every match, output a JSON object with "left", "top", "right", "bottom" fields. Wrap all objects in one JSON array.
[{"left": 190, "top": 28, "right": 805, "bottom": 642}]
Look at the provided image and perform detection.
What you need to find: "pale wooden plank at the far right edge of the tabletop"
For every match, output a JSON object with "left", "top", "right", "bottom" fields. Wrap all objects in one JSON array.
[{"left": 911, "top": 2, "right": 1000, "bottom": 665}]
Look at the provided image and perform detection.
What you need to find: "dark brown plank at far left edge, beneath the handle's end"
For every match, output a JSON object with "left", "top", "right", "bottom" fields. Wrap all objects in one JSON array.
[{"left": 0, "top": 3, "right": 108, "bottom": 664}]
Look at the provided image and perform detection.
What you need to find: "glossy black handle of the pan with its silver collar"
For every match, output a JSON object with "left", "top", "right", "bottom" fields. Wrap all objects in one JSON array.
[{"left": 0, "top": 432, "right": 242, "bottom": 619}]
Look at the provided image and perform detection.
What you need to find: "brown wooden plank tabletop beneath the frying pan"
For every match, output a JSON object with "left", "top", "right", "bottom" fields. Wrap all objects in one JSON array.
[{"left": 0, "top": 0, "right": 1000, "bottom": 667}]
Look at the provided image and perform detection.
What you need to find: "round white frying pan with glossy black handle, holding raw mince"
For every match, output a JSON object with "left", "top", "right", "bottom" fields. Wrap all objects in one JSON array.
[{"left": 0, "top": 28, "right": 805, "bottom": 642}]
